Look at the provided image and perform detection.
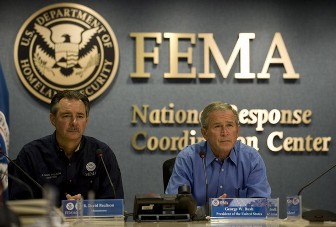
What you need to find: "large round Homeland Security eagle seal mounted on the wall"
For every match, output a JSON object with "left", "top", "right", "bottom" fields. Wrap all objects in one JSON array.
[{"left": 14, "top": 3, "right": 119, "bottom": 103}]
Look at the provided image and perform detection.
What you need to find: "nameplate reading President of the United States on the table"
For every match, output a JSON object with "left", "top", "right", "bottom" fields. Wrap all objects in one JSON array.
[{"left": 210, "top": 198, "right": 267, "bottom": 219}]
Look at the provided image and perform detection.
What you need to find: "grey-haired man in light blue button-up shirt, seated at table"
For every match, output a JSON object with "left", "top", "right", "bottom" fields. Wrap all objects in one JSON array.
[{"left": 166, "top": 102, "right": 271, "bottom": 206}]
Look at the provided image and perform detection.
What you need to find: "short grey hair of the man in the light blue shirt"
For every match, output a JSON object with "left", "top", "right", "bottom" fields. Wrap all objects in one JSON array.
[{"left": 201, "top": 102, "right": 239, "bottom": 128}]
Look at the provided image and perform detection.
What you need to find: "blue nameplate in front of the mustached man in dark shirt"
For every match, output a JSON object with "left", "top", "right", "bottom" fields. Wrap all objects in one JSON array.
[{"left": 62, "top": 199, "right": 124, "bottom": 217}]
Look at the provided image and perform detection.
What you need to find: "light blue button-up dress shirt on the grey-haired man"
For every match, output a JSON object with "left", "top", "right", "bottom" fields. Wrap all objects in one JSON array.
[{"left": 165, "top": 140, "right": 271, "bottom": 206}]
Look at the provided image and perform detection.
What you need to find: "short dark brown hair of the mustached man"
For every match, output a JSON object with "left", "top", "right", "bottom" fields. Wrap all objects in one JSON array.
[{"left": 50, "top": 90, "right": 90, "bottom": 116}]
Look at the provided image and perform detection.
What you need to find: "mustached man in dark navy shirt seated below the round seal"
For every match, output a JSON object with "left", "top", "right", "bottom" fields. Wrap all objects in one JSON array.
[{"left": 9, "top": 90, "right": 124, "bottom": 206}]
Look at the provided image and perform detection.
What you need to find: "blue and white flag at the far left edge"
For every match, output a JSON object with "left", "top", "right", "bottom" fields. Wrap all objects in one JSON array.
[{"left": 0, "top": 60, "right": 9, "bottom": 201}]
